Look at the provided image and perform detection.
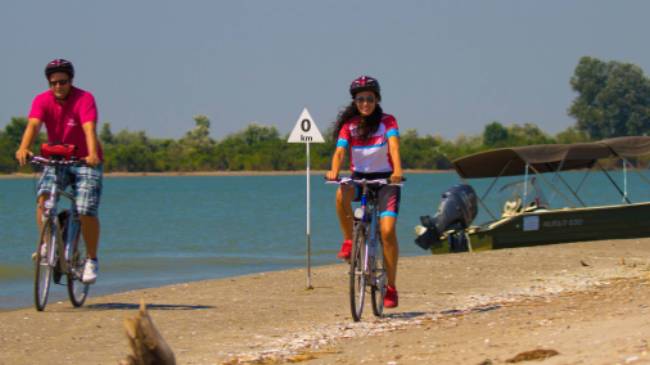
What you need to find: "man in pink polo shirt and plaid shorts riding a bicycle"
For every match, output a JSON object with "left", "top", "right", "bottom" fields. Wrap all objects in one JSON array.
[{"left": 16, "top": 59, "right": 103, "bottom": 284}]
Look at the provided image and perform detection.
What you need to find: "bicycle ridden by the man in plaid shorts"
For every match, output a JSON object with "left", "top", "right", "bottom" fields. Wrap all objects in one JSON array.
[{"left": 31, "top": 149, "right": 89, "bottom": 311}]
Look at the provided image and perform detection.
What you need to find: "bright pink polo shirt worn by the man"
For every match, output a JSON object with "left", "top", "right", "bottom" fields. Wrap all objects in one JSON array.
[{"left": 29, "top": 86, "right": 104, "bottom": 161}]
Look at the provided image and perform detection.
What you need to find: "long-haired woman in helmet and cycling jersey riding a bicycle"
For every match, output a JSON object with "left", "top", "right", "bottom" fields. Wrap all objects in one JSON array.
[{"left": 326, "top": 76, "right": 402, "bottom": 308}]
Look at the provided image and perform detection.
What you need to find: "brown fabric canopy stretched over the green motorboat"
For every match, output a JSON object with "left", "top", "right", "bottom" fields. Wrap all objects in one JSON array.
[{"left": 452, "top": 136, "right": 650, "bottom": 178}]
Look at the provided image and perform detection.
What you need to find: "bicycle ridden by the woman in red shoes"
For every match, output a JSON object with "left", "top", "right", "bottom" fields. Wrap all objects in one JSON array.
[{"left": 328, "top": 177, "right": 401, "bottom": 322}]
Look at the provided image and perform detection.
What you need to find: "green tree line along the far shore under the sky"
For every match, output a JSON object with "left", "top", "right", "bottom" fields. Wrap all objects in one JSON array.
[{"left": 0, "top": 57, "right": 650, "bottom": 173}]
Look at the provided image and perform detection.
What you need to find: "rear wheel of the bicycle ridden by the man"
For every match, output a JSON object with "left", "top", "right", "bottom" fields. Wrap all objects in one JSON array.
[{"left": 67, "top": 217, "right": 90, "bottom": 307}]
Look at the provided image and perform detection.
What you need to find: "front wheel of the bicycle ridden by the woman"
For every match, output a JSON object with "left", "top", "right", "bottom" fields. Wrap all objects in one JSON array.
[{"left": 350, "top": 222, "right": 366, "bottom": 322}]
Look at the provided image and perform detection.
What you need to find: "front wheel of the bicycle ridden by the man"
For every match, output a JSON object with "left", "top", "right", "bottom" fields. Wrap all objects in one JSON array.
[{"left": 34, "top": 218, "right": 57, "bottom": 311}]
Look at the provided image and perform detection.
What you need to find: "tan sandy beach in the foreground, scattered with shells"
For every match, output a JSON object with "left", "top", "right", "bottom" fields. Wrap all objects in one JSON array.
[{"left": 0, "top": 239, "right": 650, "bottom": 365}]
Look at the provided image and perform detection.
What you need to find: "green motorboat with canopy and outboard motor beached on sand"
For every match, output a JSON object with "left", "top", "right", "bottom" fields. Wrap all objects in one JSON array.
[{"left": 416, "top": 136, "right": 650, "bottom": 253}]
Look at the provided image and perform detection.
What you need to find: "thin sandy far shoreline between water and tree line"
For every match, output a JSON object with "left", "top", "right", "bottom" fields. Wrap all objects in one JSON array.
[{"left": 0, "top": 169, "right": 454, "bottom": 180}]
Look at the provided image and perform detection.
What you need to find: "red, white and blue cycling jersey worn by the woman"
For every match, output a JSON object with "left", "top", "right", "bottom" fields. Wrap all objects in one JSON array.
[{"left": 336, "top": 114, "right": 399, "bottom": 173}]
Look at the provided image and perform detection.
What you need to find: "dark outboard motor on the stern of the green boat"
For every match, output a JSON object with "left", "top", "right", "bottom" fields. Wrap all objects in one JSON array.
[{"left": 415, "top": 184, "right": 478, "bottom": 252}]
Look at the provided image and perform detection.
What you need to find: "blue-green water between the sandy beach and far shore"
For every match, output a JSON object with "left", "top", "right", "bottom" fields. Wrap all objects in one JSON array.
[{"left": 0, "top": 173, "right": 650, "bottom": 308}]
